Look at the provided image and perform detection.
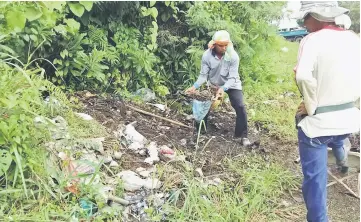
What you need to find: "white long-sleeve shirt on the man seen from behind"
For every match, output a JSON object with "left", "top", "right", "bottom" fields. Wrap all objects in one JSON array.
[{"left": 295, "top": 27, "right": 360, "bottom": 138}]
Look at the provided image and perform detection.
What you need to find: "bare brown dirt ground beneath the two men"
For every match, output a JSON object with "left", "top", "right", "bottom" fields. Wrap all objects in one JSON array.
[{"left": 80, "top": 94, "right": 360, "bottom": 222}]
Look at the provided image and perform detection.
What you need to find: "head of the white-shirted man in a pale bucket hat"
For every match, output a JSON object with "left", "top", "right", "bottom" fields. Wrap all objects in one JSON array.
[{"left": 299, "top": 1, "right": 351, "bottom": 32}]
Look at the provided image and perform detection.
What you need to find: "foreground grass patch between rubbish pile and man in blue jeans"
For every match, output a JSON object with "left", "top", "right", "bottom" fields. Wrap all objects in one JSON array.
[{"left": 161, "top": 156, "right": 298, "bottom": 222}]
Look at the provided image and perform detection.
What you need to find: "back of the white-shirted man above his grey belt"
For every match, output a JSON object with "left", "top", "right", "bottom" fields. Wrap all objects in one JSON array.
[{"left": 311, "top": 29, "right": 360, "bottom": 106}]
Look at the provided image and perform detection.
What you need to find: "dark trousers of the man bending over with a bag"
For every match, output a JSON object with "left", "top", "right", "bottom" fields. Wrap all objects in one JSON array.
[{"left": 196, "top": 89, "right": 248, "bottom": 137}]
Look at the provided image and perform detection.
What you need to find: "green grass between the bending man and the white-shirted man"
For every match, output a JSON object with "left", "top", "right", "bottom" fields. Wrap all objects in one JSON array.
[{"left": 244, "top": 41, "right": 301, "bottom": 140}]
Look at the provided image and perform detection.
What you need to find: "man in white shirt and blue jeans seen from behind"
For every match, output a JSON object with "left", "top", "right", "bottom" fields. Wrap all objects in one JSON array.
[{"left": 294, "top": 1, "right": 360, "bottom": 222}]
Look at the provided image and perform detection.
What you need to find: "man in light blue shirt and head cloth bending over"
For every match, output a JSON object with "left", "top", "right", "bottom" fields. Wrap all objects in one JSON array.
[{"left": 186, "top": 30, "right": 251, "bottom": 146}]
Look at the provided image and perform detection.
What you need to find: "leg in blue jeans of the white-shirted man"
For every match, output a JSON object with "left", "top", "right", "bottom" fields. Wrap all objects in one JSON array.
[{"left": 298, "top": 128, "right": 332, "bottom": 222}]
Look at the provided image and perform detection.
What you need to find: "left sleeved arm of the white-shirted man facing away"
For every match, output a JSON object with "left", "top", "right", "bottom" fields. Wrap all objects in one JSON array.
[{"left": 295, "top": 36, "right": 318, "bottom": 116}]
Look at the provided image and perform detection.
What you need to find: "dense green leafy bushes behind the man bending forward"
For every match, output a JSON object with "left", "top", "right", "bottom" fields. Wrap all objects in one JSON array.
[{"left": 0, "top": 2, "right": 284, "bottom": 96}]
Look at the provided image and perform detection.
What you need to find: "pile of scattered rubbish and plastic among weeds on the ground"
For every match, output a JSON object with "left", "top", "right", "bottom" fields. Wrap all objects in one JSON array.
[{"left": 34, "top": 114, "right": 186, "bottom": 221}]
